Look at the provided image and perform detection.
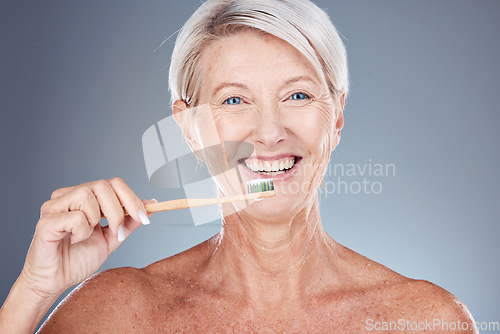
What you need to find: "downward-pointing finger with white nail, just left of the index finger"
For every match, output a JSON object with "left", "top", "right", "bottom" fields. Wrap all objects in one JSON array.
[{"left": 89, "top": 180, "right": 125, "bottom": 237}]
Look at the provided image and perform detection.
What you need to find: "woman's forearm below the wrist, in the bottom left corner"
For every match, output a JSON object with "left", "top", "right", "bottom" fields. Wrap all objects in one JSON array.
[{"left": 0, "top": 276, "right": 60, "bottom": 333}]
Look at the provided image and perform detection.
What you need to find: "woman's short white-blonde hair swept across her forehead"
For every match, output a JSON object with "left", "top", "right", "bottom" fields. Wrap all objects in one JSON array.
[{"left": 169, "top": 0, "right": 349, "bottom": 107}]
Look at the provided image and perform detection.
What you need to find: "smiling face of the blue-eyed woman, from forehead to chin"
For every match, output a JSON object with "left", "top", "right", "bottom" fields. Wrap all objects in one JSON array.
[{"left": 177, "top": 31, "right": 343, "bottom": 221}]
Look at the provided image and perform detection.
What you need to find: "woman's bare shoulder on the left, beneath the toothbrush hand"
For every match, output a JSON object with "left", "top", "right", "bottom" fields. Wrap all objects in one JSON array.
[{"left": 40, "top": 239, "right": 219, "bottom": 333}]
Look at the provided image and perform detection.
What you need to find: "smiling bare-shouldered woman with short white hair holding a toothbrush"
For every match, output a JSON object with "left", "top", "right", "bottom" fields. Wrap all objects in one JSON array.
[{"left": 0, "top": 0, "right": 474, "bottom": 333}]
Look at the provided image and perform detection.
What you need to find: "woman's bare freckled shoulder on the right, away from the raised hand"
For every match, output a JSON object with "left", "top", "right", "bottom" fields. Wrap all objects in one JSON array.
[{"left": 339, "top": 246, "right": 476, "bottom": 333}]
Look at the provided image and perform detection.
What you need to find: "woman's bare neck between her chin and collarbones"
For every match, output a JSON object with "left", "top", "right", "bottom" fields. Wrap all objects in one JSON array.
[{"left": 209, "top": 200, "right": 335, "bottom": 306}]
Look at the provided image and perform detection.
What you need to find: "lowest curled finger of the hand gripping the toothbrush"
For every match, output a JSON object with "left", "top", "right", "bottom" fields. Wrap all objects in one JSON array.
[{"left": 36, "top": 211, "right": 92, "bottom": 243}]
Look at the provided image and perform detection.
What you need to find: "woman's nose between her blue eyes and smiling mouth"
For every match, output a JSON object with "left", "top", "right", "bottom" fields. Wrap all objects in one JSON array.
[{"left": 252, "top": 111, "right": 287, "bottom": 149}]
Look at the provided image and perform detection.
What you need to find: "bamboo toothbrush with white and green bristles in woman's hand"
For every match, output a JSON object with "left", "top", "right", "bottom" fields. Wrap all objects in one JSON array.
[{"left": 102, "top": 179, "right": 276, "bottom": 218}]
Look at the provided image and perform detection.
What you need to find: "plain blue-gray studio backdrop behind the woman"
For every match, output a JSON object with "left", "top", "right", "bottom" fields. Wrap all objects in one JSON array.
[{"left": 0, "top": 0, "right": 500, "bottom": 328}]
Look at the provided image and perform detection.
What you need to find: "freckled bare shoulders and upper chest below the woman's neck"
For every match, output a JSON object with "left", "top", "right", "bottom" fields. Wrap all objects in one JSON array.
[{"left": 41, "top": 236, "right": 472, "bottom": 333}]
